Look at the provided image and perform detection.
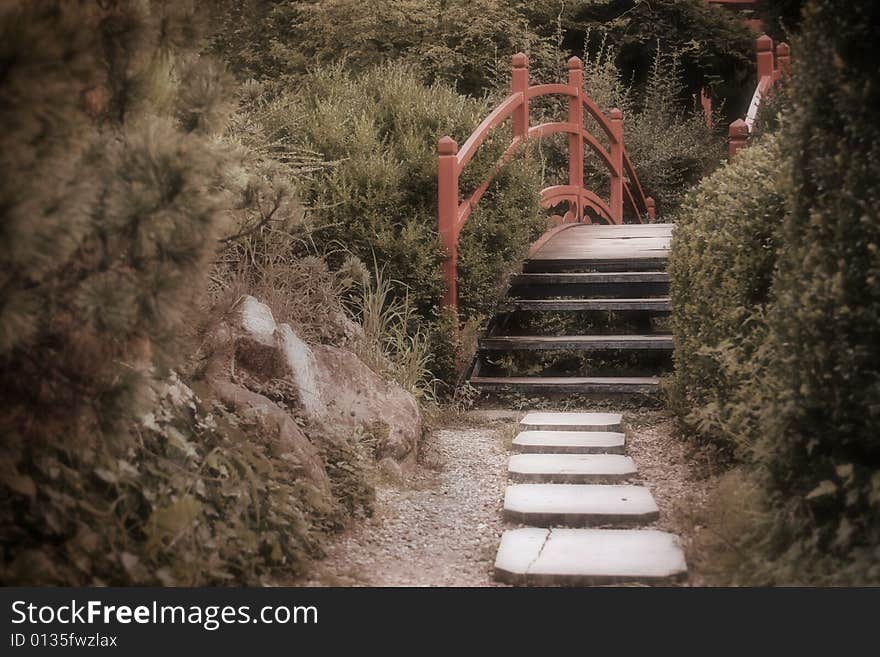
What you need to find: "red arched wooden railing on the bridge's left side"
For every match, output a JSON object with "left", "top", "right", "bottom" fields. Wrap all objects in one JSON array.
[{"left": 437, "top": 53, "right": 654, "bottom": 307}]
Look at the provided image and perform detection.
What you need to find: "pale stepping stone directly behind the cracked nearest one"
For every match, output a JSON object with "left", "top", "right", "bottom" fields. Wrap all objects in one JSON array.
[{"left": 504, "top": 484, "right": 660, "bottom": 527}]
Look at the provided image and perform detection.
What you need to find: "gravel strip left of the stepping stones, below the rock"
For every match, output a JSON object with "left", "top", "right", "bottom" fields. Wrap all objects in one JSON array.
[{"left": 308, "top": 422, "right": 512, "bottom": 586}]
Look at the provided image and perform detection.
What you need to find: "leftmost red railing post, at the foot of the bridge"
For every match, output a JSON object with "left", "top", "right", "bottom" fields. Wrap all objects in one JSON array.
[{"left": 437, "top": 137, "right": 458, "bottom": 308}]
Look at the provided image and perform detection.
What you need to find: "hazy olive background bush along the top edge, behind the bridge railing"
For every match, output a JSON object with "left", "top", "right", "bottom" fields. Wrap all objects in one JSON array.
[{"left": 215, "top": 0, "right": 547, "bottom": 95}]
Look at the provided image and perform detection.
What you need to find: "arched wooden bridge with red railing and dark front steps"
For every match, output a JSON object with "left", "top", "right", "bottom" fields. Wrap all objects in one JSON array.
[{"left": 437, "top": 53, "right": 672, "bottom": 393}]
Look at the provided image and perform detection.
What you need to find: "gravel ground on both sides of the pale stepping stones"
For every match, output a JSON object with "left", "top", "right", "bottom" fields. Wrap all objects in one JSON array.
[{"left": 306, "top": 409, "right": 712, "bottom": 586}]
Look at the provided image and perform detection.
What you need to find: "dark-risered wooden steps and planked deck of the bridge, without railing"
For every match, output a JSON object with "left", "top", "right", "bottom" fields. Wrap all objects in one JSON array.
[{"left": 469, "top": 224, "right": 673, "bottom": 396}]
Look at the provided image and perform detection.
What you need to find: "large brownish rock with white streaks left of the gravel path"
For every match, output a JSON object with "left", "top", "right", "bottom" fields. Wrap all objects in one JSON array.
[{"left": 229, "top": 296, "right": 421, "bottom": 464}]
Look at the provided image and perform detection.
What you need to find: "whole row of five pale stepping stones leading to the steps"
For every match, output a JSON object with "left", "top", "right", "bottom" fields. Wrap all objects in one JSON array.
[{"left": 495, "top": 413, "right": 687, "bottom": 586}]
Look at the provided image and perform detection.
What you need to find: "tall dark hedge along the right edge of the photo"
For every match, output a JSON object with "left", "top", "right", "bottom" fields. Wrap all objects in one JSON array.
[{"left": 756, "top": 0, "right": 880, "bottom": 582}]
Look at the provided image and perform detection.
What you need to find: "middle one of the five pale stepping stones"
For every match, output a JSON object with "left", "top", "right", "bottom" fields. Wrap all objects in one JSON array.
[{"left": 507, "top": 454, "right": 636, "bottom": 484}]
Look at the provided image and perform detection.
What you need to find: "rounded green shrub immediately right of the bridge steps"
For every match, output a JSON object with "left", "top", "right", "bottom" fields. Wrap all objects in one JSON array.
[{"left": 669, "top": 139, "right": 786, "bottom": 449}]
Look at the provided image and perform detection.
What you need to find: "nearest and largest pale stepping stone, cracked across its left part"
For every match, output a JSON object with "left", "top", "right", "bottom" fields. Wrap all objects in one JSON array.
[{"left": 495, "top": 527, "right": 687, "bottom": 586}]
